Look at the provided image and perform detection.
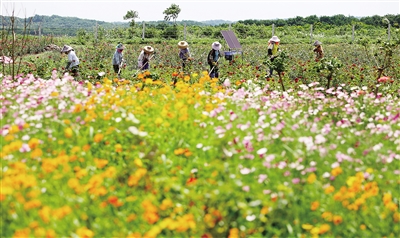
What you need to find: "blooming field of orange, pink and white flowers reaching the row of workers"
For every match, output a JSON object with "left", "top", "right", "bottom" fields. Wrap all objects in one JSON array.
[{"left": 0, "top": 40, "right": 400, "bottom": 238}]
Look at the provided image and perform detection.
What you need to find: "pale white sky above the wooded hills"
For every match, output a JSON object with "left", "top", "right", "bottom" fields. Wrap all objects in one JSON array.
[{"left": 1, "top": 0, "right": 400, "bottom": 22}]
